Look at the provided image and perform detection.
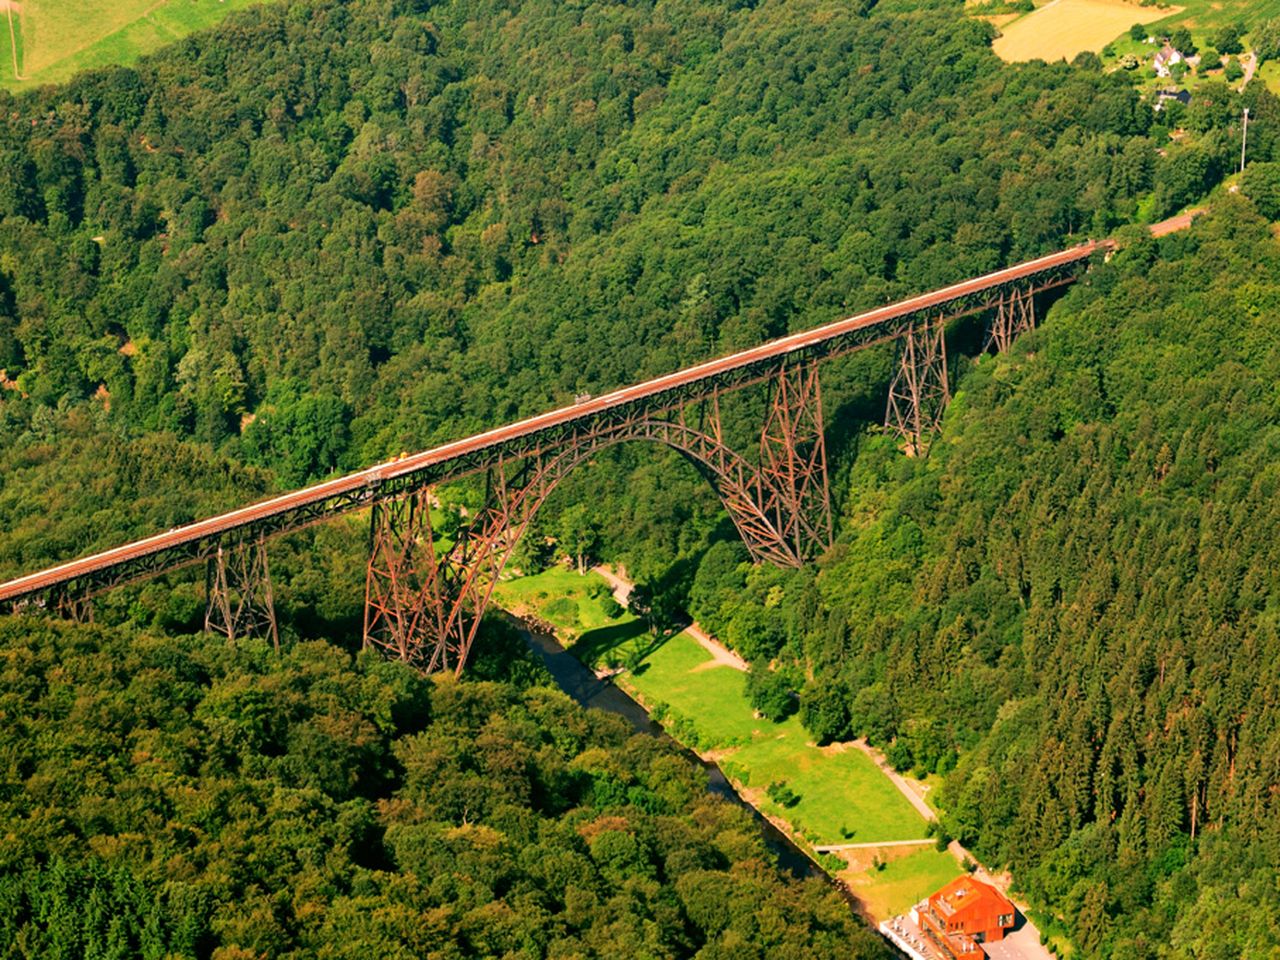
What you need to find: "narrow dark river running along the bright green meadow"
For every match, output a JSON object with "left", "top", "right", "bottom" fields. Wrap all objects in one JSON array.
[{"left": 512, "top": 618, "right": 829, "bottom": 885}]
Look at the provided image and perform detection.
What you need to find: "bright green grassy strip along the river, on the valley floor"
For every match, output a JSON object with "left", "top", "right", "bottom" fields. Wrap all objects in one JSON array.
[{"left": 499, "top": 568, "right": 961, "bottom": 920}]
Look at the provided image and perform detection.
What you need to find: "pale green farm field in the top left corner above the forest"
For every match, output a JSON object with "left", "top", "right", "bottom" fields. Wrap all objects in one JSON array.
[{"left": 0, "top": 0, "right": 279, "bottom": 90}]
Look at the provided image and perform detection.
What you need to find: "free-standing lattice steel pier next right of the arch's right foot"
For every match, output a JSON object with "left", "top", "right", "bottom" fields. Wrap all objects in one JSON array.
[{"left": 884, "top": 317, "right": 951, "bottom": 457}]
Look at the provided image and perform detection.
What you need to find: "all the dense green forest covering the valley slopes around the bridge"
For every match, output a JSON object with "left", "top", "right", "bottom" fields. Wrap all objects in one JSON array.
[{"left": 0, "top": 0, "right": 1280, "bottom": 959}]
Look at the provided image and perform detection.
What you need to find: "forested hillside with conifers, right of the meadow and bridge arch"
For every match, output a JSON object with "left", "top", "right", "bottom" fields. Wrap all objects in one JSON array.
[{"left": 692, "top": 208, "right": 1280, "bottom": 957}]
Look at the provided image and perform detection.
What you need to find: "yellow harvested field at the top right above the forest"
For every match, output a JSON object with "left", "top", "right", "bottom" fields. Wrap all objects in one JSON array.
[{"left": 992, "top": 0, "right": 1176, "bottom": 61}]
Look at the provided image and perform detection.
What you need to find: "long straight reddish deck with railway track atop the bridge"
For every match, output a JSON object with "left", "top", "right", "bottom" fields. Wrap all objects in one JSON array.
[{"left": 0, "top": 241, "right": 1111, "bottom": 603}]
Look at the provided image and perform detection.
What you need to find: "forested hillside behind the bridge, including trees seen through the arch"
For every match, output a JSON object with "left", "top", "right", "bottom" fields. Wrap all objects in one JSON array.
[{"left": 0, "top": 0, "right": 1276, "bottom": 593}]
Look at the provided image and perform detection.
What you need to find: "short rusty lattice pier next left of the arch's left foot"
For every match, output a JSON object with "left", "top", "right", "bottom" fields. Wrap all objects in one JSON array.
[{"left": 205, "top": 538, "right": 280, "bottom": 650}]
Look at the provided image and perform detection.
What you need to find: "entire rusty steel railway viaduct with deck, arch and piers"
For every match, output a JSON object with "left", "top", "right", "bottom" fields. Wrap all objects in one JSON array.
[{"left": 0, "top": 241, "right": 1112, "bottom": 672}]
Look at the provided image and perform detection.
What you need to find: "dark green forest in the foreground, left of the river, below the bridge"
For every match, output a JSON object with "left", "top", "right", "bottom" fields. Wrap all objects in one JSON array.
[{"left": 0, "top": 621, "right": 887, "bottom": 960}]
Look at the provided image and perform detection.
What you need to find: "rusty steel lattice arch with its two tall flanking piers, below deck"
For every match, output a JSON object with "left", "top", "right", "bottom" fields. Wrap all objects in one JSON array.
[{"left": 365, "top": 364, "right": 831, "bottom": 673}]
